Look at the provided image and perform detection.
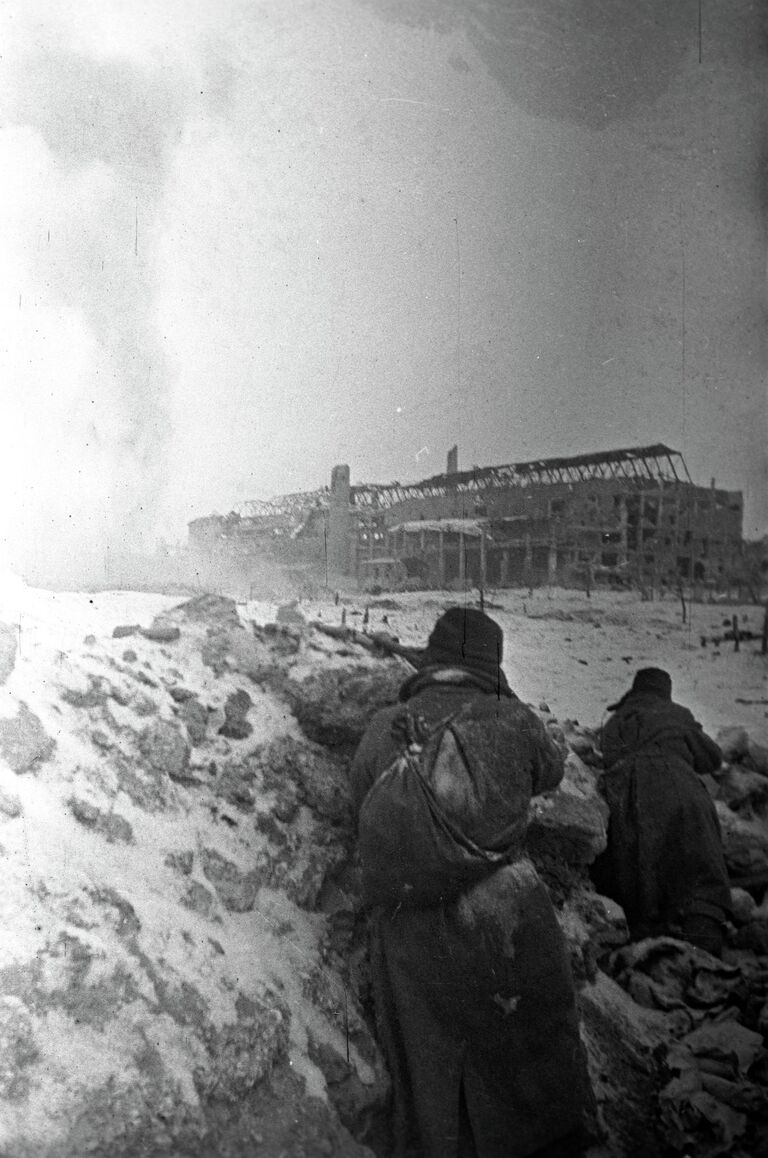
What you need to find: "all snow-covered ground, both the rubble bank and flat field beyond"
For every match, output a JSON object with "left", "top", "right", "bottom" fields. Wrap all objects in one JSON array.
[{"left": 0, "top": 574, "right": 768, "bottom": 1158}]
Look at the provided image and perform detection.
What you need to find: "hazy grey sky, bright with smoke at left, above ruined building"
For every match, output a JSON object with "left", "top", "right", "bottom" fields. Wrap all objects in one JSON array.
[{"left": 0, "top": 0, "right": 768, "bottom": 565}]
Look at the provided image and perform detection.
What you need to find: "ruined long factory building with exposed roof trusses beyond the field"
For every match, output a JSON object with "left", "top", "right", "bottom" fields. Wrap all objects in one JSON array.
[{"left": 189, "top": 444, "right": 743, "bottom": 589}]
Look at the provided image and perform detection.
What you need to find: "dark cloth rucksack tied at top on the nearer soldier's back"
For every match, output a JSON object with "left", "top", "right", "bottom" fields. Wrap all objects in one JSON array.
[{"left": 358, "top": 697, "right": 528, "bottom": 908}]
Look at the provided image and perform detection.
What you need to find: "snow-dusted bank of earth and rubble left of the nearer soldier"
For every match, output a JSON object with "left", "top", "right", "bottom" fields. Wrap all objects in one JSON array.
[{"left": 0, "top": 574, "right": 384, "bottom": 1158}]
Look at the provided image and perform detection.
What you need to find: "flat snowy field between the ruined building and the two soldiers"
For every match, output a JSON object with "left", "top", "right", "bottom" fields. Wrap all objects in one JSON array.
[{"left": 276, "top": 588, "right": 768, "bottom": 743}]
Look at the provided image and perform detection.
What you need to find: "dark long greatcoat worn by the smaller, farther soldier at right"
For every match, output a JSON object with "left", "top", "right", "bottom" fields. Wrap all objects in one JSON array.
[{"left": 592, "top": 692, "right": 731, "bottom": 939}]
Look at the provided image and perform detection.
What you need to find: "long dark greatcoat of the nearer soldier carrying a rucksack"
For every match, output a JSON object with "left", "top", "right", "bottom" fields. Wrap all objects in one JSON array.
[{"left": 352, "top": 673, "right": 590, "bottom": 1158}]
